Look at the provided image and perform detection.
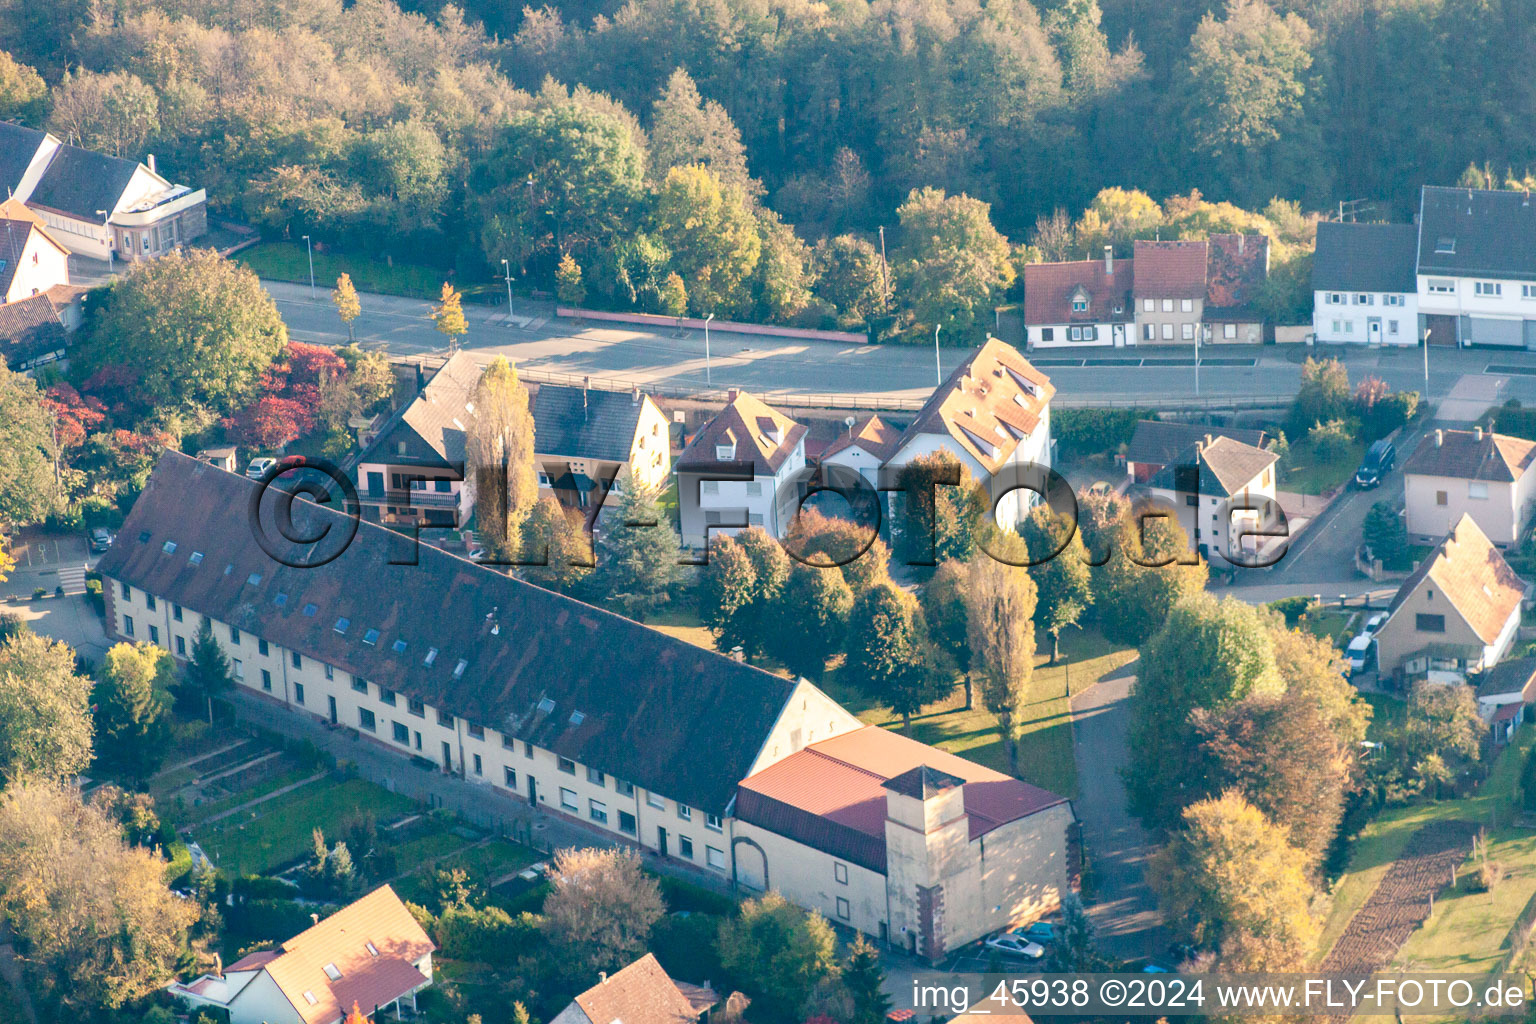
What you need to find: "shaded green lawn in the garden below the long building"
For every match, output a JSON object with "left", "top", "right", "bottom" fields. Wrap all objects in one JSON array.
[{"left": 192, "top": 778, "right": 413, "bottom": 875}]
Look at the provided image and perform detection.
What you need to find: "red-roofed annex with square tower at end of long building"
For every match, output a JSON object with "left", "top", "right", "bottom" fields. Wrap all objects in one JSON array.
[{"left": 736, "top": 726, "right": 1077, "bottom": 961}]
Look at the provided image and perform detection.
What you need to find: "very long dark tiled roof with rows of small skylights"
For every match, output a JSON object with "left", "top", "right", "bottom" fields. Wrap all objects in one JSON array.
[{"left": 98, "top": 451, "right": 794, "bottom": 814}]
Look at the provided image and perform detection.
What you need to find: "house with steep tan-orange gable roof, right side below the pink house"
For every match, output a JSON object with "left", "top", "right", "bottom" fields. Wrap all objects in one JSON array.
[{"left": 1376, "top": 514, "right": 1525, "bottom": 679}]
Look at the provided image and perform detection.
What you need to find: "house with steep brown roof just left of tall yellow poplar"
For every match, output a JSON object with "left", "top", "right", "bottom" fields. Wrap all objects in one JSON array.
[{"left": 355, "top": 352, "right": 481, "bottom": 527}]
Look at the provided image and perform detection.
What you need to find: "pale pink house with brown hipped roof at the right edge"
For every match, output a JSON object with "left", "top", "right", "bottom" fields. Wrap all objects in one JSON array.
[{"left": 1402, "top": 427, "right": 1536, "bottom": 548}]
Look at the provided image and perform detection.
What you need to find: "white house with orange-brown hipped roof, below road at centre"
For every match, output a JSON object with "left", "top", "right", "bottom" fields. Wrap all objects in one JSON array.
[{"left": 677, "top": 388, "right": 806, "bottom": 548}]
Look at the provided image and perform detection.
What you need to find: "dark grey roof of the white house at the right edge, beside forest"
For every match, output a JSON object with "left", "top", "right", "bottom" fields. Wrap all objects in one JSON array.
[{"left": 1419, "top": 184, "right": 1536, "bottom": 281}]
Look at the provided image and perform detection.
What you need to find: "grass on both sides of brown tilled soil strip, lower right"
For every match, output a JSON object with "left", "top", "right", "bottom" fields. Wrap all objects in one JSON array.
[{"left": 1318, "top": 724, "right": 1536, "bottom": 972}]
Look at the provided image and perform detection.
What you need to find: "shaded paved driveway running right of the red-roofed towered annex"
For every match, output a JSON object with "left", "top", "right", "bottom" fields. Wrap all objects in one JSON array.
[{"left": 1072, "top": 662, "right": 1167, "bottom": 960}]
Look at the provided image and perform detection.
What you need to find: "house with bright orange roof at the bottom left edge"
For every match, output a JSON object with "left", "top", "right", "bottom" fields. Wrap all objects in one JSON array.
[{"left": 167, "top": 886, "right": 436, "bottom": 1024}]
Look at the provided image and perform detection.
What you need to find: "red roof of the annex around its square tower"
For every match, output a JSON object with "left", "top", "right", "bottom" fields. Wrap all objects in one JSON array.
[{"left": 736, "top": 726, "right": 1066, "bottom": 872}]
